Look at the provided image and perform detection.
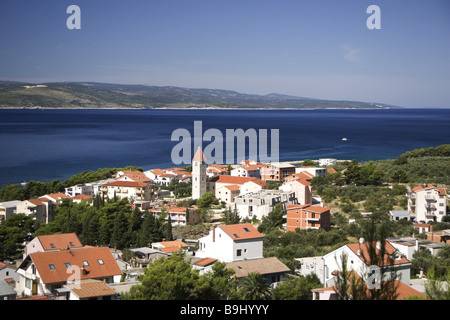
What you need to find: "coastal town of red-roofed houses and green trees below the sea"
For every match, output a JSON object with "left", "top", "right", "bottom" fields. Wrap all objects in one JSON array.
[{"left": 0, "top": 148, "right": 450, "bottom": 300}]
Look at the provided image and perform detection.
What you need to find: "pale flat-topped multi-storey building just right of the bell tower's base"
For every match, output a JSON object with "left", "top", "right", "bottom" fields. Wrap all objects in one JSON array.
[{"left": 234, "top": 190, "right": 297, "bottom": 220}]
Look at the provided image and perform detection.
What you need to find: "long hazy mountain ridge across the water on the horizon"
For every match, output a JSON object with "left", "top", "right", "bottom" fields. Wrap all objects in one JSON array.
[{"left": 0, "top": 81, "right": 395, "bottom": 109}]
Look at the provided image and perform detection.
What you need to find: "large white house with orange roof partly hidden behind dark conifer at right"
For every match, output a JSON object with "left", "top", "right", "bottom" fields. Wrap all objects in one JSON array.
[{"left": 317, "top": 239, "right": 411, "bottom": 287}]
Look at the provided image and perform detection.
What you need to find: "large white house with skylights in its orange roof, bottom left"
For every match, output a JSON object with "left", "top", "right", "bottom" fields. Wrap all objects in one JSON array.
[{"left": 17, "top": 247, "right": 122, "bottom": 296}]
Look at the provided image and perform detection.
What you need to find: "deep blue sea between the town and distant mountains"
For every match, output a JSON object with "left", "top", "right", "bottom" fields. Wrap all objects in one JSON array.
[{"left": 0, "top": 109, "right": 450, "bottom": 186}]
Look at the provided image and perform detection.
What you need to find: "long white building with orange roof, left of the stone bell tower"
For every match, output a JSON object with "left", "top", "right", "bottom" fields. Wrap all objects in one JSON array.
[{"left": 102, "top": 181, "right": 152, "bottom": 203}]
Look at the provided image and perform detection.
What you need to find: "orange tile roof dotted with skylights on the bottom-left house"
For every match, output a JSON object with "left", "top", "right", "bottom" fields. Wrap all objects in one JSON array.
[{"left": 30, "top": 247, "right": 122, "bottom": 284}]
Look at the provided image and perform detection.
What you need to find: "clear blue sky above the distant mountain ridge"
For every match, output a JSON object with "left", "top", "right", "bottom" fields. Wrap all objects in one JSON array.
[{"left": 0, "top": 0, "right": 450, "bottom": 108}]
